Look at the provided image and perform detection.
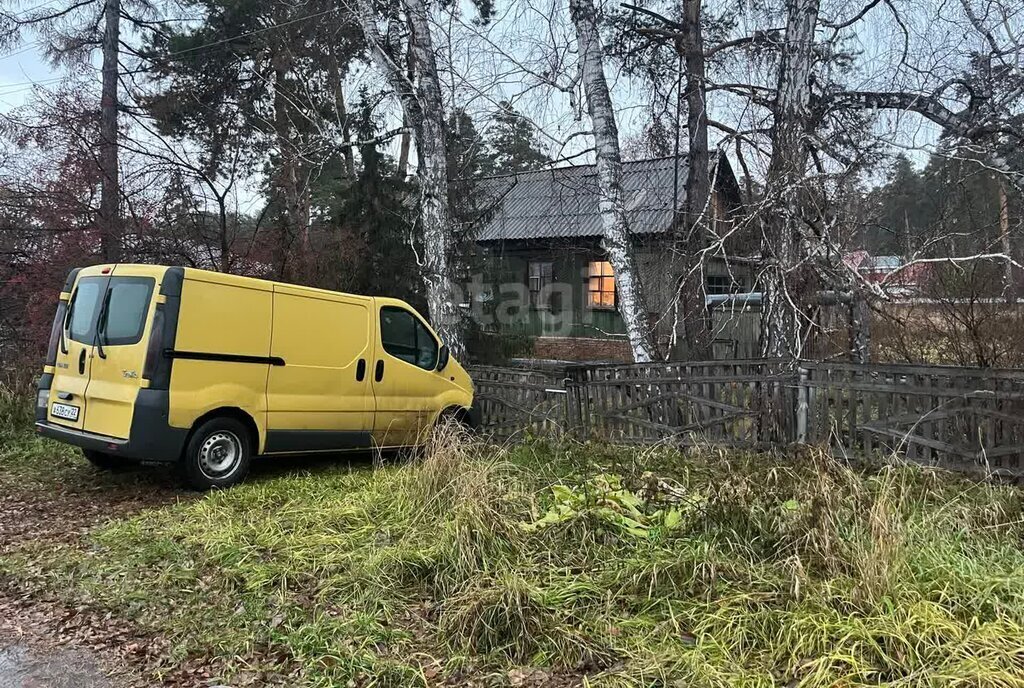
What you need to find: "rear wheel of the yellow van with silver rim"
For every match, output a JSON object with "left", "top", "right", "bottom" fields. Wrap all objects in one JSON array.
[{"left": 181, "top": 416, "right": 252, "bottom": 490}]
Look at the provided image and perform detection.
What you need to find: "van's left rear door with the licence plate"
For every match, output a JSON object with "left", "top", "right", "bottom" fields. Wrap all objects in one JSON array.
[{"left": 46, "top": 267, "right": 108, "bottom": 430}]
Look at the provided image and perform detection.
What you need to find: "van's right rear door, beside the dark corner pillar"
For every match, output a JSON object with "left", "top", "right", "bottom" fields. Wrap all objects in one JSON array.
[{"left": 82, "top": 265, "right": 159, "bottom": 439}]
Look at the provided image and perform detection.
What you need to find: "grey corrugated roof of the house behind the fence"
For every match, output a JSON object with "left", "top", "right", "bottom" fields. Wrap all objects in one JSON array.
[{"left": 476, "top": 158, "right": 686, "bottom": 242}]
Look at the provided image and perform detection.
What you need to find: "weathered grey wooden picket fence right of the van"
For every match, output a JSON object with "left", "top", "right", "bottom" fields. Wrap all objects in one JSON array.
[{"left": 471, "top": 360, "right": 1024, "bottom": 476}]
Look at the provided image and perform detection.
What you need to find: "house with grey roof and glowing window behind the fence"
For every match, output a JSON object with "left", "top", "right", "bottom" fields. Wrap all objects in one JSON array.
[{"left": 473, "top": 157, "right": 758, "bottom": 360}]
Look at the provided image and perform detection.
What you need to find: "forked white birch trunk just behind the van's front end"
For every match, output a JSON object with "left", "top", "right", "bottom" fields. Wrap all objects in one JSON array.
[{"left": 357, "top": 0, "right": 465, "bottom": 357}]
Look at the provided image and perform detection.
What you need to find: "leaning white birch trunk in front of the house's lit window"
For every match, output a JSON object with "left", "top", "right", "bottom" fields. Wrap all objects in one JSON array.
[{"left": 569, "top": 0, "right": 655, "bottom": 363}]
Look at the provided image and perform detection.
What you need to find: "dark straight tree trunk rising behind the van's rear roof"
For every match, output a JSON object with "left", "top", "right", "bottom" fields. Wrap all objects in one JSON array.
[{"left": 99, "top": 0, "right": 122, "bottom": 263}]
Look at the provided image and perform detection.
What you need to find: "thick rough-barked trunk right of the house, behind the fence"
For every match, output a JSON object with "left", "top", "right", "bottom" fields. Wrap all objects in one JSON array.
[{"left": 761, "top": 0, "right": 819, "bottom": 359}]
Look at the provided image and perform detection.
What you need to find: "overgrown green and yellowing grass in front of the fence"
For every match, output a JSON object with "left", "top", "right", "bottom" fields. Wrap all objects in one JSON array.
[{"left": 0, "top": 389, "right": 1024, "bottom": 687}]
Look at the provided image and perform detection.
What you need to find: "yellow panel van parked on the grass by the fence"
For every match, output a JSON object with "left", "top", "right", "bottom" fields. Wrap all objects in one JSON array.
[{"left": 36, "top": 263, "right": 476, "bottom": 488}]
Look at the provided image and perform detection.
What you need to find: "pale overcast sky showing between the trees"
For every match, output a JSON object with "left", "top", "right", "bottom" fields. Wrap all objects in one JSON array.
[{"left": 0, "top": 0, "right": 955, "bottom": 196}]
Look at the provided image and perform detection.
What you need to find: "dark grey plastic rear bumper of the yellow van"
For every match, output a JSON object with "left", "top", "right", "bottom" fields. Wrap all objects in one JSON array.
[{"left": 36, "top": 389, "right": 188, "bottom": 464}]
